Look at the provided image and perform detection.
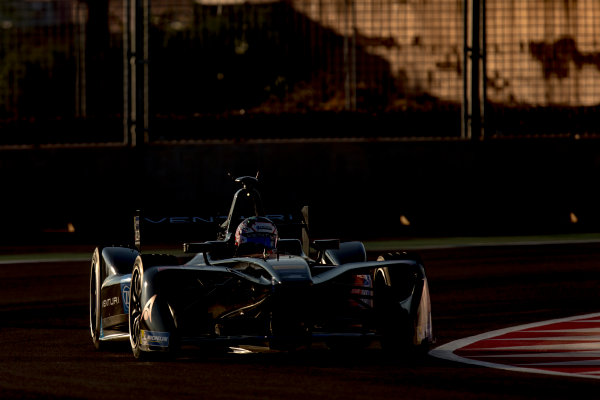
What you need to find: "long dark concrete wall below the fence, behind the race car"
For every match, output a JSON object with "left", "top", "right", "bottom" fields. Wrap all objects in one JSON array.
[{"left": 0, "top": 140, "right": 600, "bottom": 242}]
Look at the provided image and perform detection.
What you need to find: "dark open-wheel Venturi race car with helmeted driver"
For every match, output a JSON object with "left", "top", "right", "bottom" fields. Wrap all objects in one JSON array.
[{"left": 89, "top": 176, "right": 433, "bottom": 358}]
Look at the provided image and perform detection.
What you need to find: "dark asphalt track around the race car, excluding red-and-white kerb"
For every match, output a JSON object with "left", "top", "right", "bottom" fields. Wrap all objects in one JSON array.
[{"left": 0, "top": 243, "right": 600, "bottom": 400}]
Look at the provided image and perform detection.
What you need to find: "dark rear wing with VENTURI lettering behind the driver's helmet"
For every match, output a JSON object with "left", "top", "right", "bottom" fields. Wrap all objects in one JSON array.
[{"left": 133, "top": 207, "right": 309, "bottom": 254}]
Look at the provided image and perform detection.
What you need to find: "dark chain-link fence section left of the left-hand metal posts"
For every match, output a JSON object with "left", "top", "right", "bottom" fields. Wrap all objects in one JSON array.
[{"left": 0, "top": 0, "right": 123, "bottom": 145}]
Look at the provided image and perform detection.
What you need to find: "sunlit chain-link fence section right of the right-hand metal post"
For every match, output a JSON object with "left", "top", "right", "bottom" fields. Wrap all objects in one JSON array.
[{"left": 485, "top": 0, "right": 600, "bottom": 136}]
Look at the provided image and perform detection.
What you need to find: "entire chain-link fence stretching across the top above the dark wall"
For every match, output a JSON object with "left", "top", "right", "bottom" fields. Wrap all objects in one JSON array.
[{"left": 0, "top": 0, "right": 600, "bottom": 145}]
